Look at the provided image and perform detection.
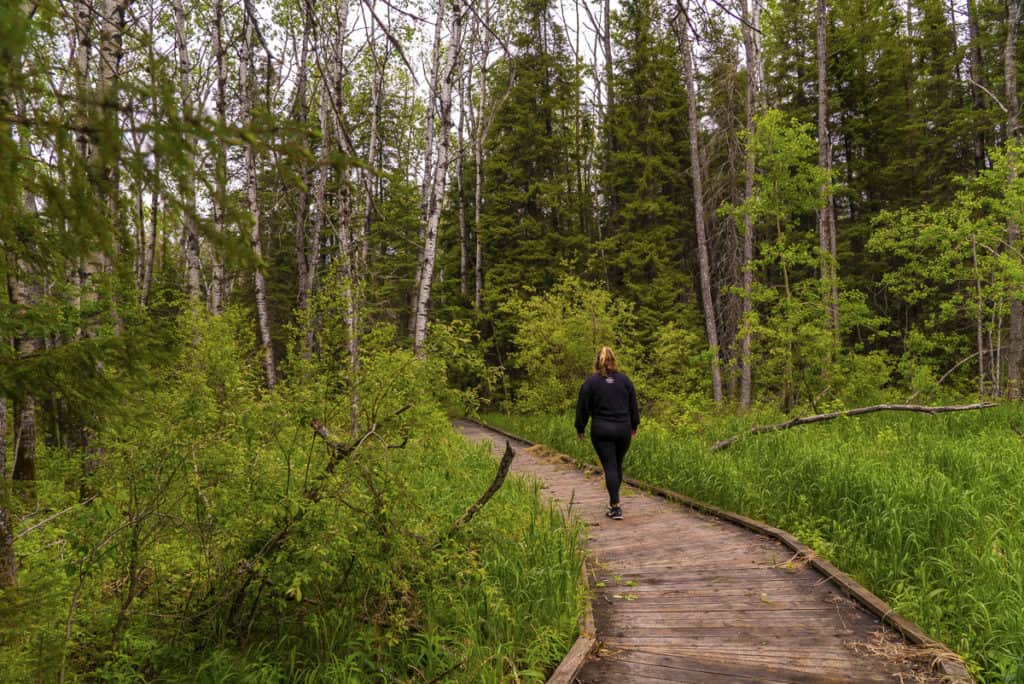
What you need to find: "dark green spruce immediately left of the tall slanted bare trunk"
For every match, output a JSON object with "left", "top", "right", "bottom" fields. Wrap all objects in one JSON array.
[{"left": 589, "top": 0, "right": 695, "bottom": 333}]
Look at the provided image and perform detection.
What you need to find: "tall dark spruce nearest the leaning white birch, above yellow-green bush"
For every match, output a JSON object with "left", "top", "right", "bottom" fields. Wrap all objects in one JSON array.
[{"left": 479, "top": 0, "right": 589, "bottom": 310}]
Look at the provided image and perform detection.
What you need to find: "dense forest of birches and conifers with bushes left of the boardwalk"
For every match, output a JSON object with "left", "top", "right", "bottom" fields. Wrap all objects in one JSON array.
[{"left": 0, "top": 0, "right": 1024, "bottom": 681}]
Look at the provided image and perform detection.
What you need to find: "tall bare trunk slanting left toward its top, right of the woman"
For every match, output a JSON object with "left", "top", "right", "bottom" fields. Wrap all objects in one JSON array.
[{"left": 676, "top": 2, "right": 723, "bottom": 403}]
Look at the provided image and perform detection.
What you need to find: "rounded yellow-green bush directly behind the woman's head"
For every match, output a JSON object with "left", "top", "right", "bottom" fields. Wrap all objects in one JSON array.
[{"left": 502, "top": 275, "right": 641, "bottom": 413}]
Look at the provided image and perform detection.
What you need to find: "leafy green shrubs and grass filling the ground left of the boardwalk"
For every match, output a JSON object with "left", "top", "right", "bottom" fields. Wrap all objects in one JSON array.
[{"left": 0, "top": 315, "right": 583, "bottom": 684}]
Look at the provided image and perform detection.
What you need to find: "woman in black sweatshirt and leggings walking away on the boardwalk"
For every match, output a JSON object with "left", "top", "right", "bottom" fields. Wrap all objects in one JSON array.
[{"left": 575, "top": 347, "right": 640, "bottom": 520}]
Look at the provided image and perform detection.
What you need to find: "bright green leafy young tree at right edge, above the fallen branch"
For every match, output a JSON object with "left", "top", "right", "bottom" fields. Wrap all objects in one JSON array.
[{"left": 867, "top": 145, "right": 1024, "bottom": 396}]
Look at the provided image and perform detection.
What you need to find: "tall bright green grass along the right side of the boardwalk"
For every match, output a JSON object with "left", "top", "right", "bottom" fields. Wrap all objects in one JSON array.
[{"left": 486, "top": 405, "right": 1024, "bottom": 682}]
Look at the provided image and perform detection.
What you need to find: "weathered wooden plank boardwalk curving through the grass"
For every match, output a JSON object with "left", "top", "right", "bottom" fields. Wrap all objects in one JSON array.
[{"left": 457, "top": 421, "right": 969, "bottom": 684}]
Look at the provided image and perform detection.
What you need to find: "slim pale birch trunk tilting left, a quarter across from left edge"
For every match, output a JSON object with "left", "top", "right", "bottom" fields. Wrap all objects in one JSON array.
[{"left": 239, "top": 0, "right": 278, "bottom": 388}]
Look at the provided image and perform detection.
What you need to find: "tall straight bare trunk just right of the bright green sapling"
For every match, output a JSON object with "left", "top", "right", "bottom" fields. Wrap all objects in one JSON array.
[{"left": 817, "top": 0, "right": 839, "bottom": 335}]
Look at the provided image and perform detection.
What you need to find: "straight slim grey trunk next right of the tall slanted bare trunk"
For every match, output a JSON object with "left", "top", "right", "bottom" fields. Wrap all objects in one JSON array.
[{"left": 739, "top": 0, "right": 763, "bottom": 410}]
